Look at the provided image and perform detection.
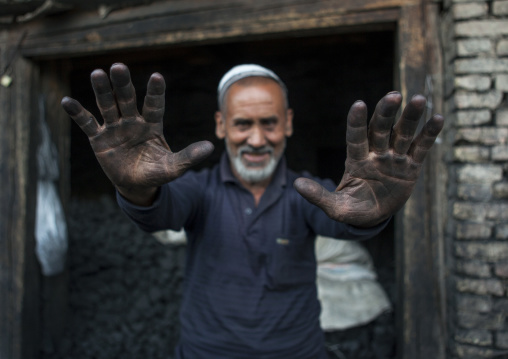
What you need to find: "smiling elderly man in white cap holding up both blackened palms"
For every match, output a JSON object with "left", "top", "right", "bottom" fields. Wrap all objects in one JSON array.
[{"left": 62, "top": 64, "right": 443, "bottom": 359}]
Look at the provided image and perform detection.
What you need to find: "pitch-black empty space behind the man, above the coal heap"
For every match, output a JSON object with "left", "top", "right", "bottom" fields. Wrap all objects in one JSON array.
[{"left": 71, "top": 32, "right": 394, "bottom": 196}]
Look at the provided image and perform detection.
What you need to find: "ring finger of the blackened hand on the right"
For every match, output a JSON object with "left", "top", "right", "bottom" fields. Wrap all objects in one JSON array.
[{"left": 391, "top": 95, "right": 426, "bottom": 155}]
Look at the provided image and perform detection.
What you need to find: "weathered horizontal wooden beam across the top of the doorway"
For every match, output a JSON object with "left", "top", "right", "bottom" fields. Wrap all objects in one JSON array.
[{"left": 18, "top": 0, "right": 400, "bottom": 57}]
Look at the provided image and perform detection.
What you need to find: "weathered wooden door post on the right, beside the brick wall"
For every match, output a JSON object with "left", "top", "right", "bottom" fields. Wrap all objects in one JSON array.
[{"left": 396, "top": 1, "right": 446, "bottom": 359}]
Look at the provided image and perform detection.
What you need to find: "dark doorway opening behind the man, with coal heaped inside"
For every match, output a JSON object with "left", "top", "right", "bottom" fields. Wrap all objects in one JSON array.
[{"left": 58, "top": 31, "right": 396, "bottom": 358}]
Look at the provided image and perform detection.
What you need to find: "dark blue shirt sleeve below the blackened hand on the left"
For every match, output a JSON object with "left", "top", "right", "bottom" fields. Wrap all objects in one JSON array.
[{"left": 116, "top": 172, "right": 205, "bottom": 232}]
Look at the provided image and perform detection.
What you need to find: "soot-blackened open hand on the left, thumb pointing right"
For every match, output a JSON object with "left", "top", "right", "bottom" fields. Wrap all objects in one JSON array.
[{"left": 62, "top": 63, "right": 213, "bottom": 206}]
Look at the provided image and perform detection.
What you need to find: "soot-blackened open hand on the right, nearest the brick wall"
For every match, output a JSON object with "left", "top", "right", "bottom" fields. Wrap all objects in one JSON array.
[{"left": 294, "top": 92, "right": 444, "bottom": 227}]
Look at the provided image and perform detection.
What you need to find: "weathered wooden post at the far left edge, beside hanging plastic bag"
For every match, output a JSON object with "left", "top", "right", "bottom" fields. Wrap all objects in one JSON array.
[{"left": 0, "top": 31, "right": 40, "bottom": 359}]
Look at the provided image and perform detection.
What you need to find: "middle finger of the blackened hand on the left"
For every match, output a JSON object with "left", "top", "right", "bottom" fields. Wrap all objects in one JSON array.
[{"left": 109, "top": 63, "right": 139, "bottom": 117}]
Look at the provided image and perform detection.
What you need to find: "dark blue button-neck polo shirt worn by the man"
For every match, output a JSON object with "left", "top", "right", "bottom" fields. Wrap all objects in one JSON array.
[{"left": 117, "top": 155, "right": 386, "bottom": 359}]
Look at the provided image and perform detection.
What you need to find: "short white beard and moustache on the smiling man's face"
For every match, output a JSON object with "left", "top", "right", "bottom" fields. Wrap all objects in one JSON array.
[{"left": 226, "top": 138, "right": 286, "bottom": 183}]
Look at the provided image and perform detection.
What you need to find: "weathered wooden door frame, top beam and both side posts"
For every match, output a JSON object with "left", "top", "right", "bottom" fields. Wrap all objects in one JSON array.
[{"left": 0, "top": 0, "right": 446, "bottom": 359}]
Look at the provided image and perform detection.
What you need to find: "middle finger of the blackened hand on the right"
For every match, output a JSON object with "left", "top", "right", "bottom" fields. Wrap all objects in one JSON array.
[{"left": 369, "top": 92, "right": 402, "bottom": 153}]
